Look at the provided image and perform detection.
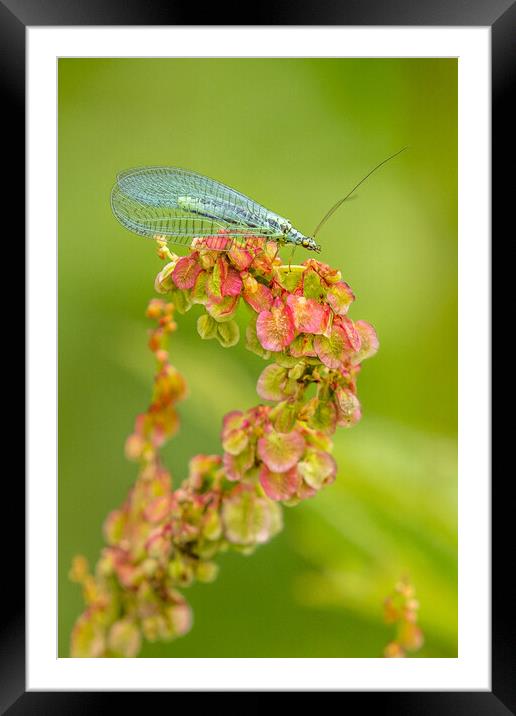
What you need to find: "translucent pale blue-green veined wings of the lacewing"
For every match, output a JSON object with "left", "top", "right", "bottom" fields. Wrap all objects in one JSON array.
[{"left": 111, "top": 167, "right": 285, "bottom": 245}]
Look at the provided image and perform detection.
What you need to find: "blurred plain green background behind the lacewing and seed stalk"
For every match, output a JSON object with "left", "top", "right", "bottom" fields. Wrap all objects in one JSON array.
[{"left": 58, "top": 59, "right": 457, "bottom": 657}]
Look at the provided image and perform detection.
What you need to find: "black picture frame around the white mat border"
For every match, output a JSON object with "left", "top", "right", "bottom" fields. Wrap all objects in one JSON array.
[{"left": 6, "top": 0, "right": 506, "bottom": 716}]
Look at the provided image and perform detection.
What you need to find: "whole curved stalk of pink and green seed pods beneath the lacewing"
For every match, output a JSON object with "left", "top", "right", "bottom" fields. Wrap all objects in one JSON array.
[{"left": 70, "top": 235, "right": 378, "bottom": 657}]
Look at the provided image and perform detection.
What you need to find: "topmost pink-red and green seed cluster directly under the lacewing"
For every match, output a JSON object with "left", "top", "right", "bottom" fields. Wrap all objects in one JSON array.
[{"left": 155, "top": 237, "right": 378, "bottom": 374}]
